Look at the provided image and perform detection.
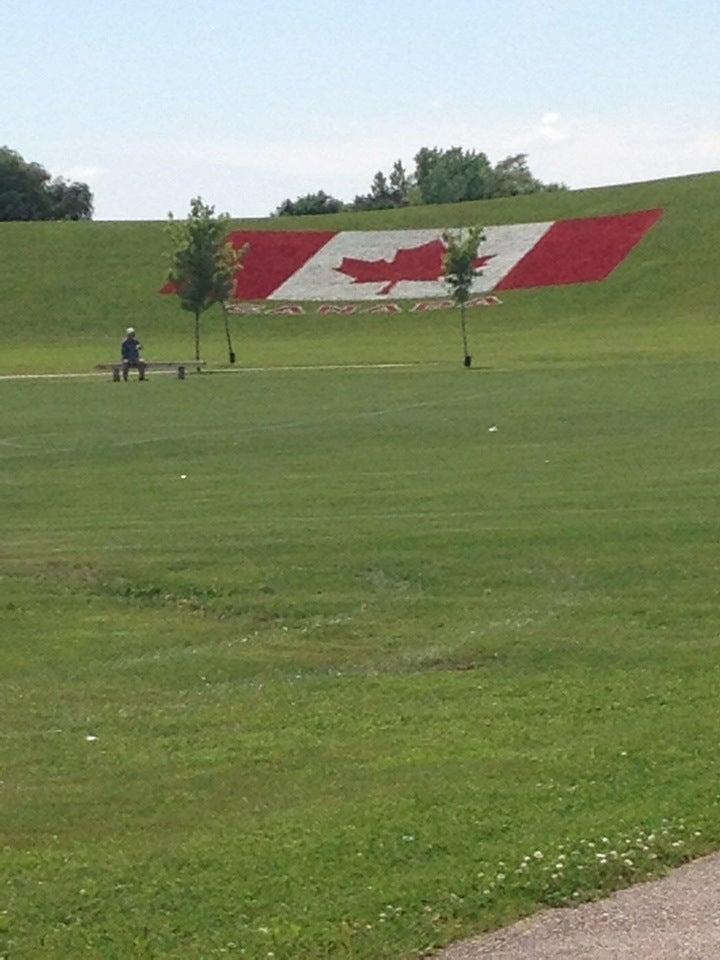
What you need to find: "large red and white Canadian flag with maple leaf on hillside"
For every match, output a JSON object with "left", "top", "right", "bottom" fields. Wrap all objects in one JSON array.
[{"left": 231, "top": 210, "right": 662, "bottom": 301}]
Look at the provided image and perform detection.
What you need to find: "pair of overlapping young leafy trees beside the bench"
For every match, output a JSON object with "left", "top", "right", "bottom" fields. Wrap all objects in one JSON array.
[{"left": 166, "top": 197, "right": 247, "bottom": 369}]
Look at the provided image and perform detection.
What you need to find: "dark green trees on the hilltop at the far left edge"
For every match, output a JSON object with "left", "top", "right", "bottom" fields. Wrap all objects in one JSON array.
[{"left": 0, "top": 147, "right": 93, "bottom": 221}]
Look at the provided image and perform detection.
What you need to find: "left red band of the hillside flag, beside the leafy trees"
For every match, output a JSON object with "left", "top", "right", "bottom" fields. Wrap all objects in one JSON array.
[{"left": 230, "top": 230, "right": 335, "bottom": 300}]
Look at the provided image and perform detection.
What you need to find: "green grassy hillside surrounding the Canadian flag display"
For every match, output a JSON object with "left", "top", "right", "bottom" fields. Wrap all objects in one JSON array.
[{"left": 0, "top": 173, "right": 720, "bottom": 372}]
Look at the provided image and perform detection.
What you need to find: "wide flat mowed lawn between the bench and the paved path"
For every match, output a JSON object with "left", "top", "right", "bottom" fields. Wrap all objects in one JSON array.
[{"left": 0, "top": 359, "right": 720, "bottom": 960}]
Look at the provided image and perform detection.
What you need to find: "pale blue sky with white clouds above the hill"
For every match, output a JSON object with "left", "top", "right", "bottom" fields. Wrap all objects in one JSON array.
[{"left": 0, "top": 0, "right": 720, "bottom": 220}]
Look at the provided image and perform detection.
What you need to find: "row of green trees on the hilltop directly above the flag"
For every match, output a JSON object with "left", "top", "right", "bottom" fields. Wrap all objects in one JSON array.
[{"left": 272, "top": 147, "right": 567, "bottom": 217}]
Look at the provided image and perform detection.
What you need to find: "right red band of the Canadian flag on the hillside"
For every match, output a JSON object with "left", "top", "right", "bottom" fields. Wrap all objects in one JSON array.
[{"left": 496, "top": 210, "right": 662, "bottom": 290}]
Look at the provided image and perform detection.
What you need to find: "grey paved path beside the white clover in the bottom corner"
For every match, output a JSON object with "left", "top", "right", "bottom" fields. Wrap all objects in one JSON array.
[{"left": 436, "top": 854, "right": 720, "bottom": 960}]
